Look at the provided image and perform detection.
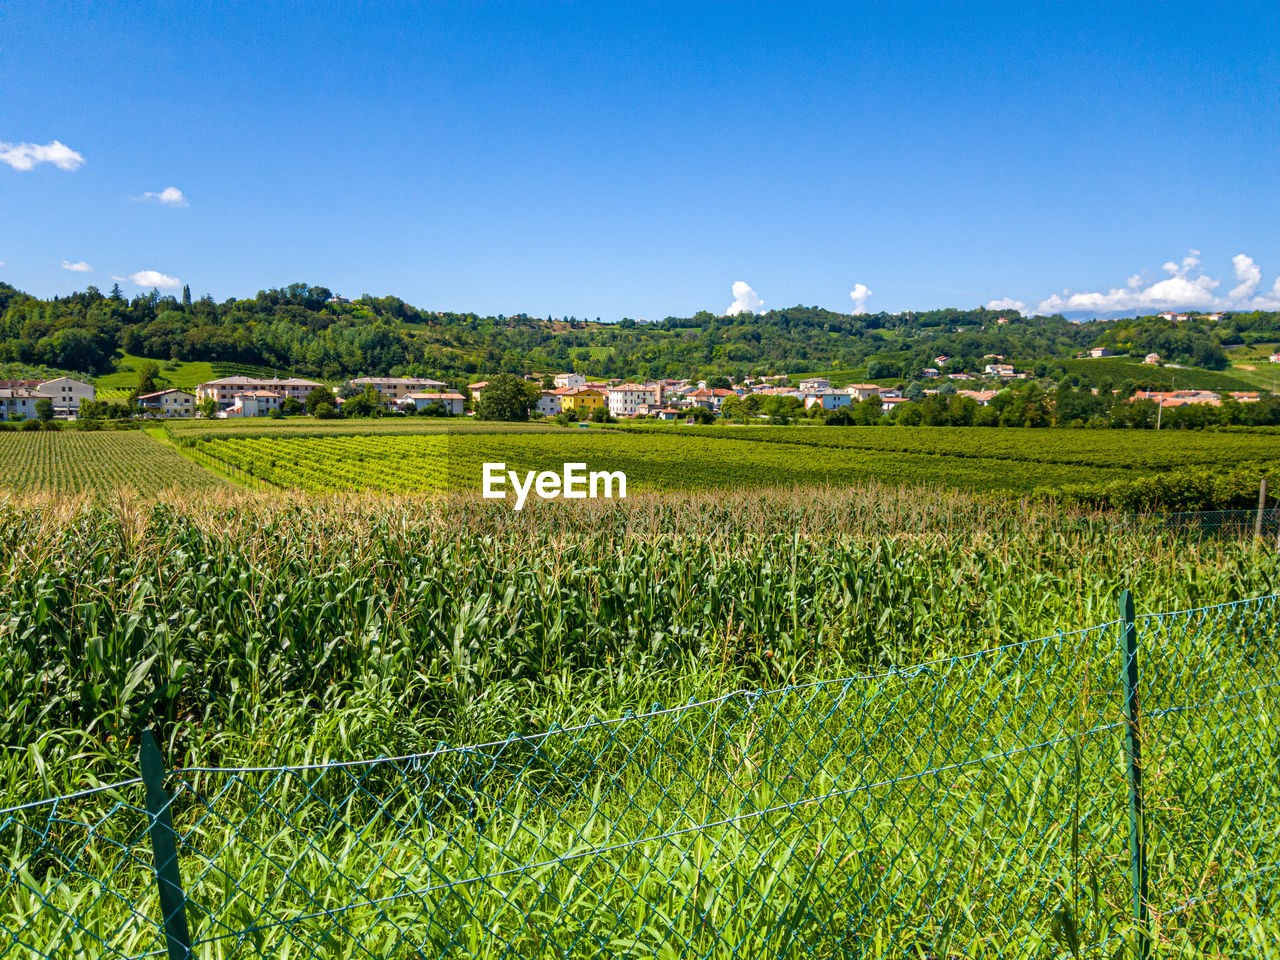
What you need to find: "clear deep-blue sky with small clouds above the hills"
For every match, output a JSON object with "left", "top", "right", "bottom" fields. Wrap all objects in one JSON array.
[{"left": 0, "top": 0, "right": 1280, "bottom": 320}]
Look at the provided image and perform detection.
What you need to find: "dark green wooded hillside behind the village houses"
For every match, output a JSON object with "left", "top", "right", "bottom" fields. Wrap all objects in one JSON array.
[{"left": 0, "top": 283, "right": 1280, "bottom": 380}]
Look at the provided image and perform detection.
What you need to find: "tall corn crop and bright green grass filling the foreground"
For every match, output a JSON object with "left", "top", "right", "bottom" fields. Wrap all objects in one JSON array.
[{"left": 0, "top": 491, "right": 1280, "bottom": 960}]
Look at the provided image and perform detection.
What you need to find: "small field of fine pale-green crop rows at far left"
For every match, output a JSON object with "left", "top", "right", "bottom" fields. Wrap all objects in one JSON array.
[{"left": 0, "top": 430, "right": 224, "bottom": 497}]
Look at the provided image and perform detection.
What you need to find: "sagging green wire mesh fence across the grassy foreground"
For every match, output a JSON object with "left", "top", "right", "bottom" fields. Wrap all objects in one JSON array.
[{"left": 0, "top": 596, "right": 1280, "bottom": 959}]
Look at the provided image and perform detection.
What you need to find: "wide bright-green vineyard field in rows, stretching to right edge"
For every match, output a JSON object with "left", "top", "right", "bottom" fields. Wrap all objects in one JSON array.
[{"left": 172, "top": 421, "right": 1280, "bottom": 504}]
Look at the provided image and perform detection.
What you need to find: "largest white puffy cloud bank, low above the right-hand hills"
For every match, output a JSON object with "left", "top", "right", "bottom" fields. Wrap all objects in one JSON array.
[{"left": 987, "top": 250, "right": 1280, "bottom": 316}]
